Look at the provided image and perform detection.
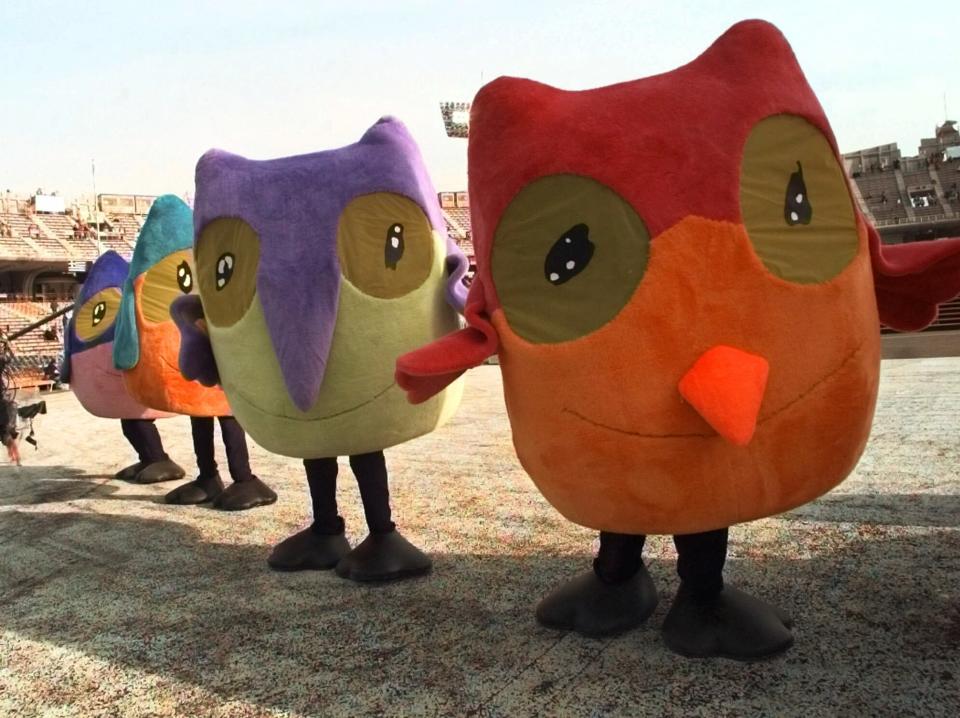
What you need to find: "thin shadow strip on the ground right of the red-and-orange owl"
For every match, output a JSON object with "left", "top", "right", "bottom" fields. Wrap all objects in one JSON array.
[{"left": 784, "top": 492, "right": 960, "bottom": 528}]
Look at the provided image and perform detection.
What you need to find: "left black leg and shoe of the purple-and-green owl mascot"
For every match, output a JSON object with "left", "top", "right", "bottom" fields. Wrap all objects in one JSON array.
[{"left": 267, "top": 456, "right": 350, "bottom": 571}]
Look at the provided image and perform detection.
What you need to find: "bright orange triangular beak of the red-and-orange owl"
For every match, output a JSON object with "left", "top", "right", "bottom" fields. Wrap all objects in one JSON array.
[{"left": 679, "top": 345, "right": 770, "bottom": 446}]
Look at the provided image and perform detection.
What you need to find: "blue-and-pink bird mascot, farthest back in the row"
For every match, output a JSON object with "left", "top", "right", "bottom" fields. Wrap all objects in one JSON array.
[{"left": 60, "top": 251, "right": 184, "bottom": 483}]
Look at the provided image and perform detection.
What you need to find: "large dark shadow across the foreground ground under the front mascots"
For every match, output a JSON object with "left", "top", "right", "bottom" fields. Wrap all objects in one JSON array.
[{"left": 0, "top": 512, "right": 960, "bottom": 716}]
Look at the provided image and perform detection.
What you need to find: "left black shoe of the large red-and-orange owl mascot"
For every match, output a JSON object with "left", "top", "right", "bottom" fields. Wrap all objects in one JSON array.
[{"left": 536, "top": 565, "right": 657, "bottom": 638}]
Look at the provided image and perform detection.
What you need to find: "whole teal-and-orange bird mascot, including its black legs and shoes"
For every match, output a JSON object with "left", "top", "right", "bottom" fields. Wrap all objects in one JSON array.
[{"left": 113, "top": 195, "right": 277, "bottom": 510}]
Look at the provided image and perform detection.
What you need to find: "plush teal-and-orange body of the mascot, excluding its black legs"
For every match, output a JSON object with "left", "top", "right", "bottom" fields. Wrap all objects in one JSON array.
[{"left": 113, "top": 195, "right": 231, "bottom": 416}]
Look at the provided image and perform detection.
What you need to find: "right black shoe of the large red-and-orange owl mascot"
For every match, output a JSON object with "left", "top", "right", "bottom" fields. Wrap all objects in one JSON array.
[{"left": 663, "top": 584, "right": 793, "bottom": 661}]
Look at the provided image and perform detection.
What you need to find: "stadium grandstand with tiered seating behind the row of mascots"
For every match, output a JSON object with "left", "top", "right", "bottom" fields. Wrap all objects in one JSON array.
[{"left": 0, "top": 118, "right": 960, "bottom": 388}]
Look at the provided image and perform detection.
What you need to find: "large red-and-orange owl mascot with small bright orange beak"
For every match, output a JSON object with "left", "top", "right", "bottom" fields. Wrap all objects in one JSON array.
[{"left": 397, "top": 21, "right": 960, "bottom": 658}]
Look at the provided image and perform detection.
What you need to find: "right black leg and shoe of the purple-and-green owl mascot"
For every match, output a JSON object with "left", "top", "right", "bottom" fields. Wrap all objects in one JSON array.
[{"left": 337, "top": 451, "right": 433, "bottom": 581}]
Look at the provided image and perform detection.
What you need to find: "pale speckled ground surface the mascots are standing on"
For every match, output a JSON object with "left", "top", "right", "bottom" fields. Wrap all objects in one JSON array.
[{"left": 0, "top": 366, "right": 960, "bottom": 717}]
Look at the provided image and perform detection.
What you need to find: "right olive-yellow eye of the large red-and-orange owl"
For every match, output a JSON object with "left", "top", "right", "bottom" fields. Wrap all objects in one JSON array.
[{"left": 740, "top": 115, "right": 859, "bottom": 284}]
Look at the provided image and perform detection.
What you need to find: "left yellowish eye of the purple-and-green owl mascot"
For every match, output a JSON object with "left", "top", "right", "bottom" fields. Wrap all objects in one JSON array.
[{"left": 197, "top": 217, "right": 260, "bottom": 327}]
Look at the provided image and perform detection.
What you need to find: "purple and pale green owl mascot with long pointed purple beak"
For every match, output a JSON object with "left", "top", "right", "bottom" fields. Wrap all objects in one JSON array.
[{"left": 175, "top": 118, "right": 466, "bottom": 580}]
